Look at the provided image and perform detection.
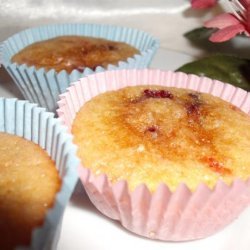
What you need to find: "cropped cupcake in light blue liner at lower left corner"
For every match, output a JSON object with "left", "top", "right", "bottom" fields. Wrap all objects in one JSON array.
[{"left": 0, "top": 98, "right": 78, "bottom": 250}]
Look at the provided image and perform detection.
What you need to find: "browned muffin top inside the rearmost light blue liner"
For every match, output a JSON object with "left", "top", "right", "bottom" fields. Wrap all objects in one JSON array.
[{"left": 11, "top": 36, "right": 140, "bottom": 73}]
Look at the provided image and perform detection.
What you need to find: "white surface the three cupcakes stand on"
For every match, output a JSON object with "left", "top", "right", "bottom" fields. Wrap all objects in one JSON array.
[{"left": 0, "top": 49, "right": 250, "bottom": 250}]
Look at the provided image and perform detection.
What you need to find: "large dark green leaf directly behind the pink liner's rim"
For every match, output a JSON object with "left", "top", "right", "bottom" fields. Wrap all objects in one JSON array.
[{"left": 176, "top": 55, "right": 250, "bottom": 91}]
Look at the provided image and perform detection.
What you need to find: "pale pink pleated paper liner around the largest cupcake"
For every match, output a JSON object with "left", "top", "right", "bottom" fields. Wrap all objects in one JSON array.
[{"left": 58, "top": 69, "right": 250, "bottom": 241}]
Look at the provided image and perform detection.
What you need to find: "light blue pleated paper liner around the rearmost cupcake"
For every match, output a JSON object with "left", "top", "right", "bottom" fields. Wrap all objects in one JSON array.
[{"left": 0, "top": 24, "right": 159, "bottom": 112}]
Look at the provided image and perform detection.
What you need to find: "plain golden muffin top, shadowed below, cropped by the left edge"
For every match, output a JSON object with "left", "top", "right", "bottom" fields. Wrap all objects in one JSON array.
[{"left": 0, "top": 132, "right": 61, "bottom": 250}]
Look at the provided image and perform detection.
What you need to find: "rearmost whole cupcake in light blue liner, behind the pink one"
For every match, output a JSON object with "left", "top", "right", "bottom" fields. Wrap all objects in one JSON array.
[{"left": 1, "top": 24, "right": 159, "bottom": 111}]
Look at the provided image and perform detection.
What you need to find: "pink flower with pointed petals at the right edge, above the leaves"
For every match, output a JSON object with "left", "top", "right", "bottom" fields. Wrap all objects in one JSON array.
[{"left": 205, "top": 0, "right": 250, "bottom": 42}]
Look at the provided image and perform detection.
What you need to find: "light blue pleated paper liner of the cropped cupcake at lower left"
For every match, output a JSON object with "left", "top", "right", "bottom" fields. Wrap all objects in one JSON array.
[{"left": 0, "top": 98, "right": 79, "bottom": 250}]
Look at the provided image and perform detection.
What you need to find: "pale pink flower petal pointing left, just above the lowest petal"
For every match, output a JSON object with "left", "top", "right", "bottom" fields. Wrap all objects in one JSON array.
[{"left": 204, "top": 13, "right": 240, "bottom": 29}]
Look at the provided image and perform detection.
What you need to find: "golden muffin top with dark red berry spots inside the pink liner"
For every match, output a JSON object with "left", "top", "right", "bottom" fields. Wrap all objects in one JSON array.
[{"left": 72, "top": 85, "right": 250, "bottom": 191}]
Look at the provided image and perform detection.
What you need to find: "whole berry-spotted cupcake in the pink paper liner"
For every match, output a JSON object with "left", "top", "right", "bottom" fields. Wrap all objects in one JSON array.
[{"left": 58, "top": 70, "right": 250, "bottom": 241}]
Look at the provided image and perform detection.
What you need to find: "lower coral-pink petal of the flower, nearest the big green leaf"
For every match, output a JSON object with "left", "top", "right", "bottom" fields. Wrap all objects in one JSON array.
[{"left": 209, "top": 24, "right": 245, "bottom": 43}]
